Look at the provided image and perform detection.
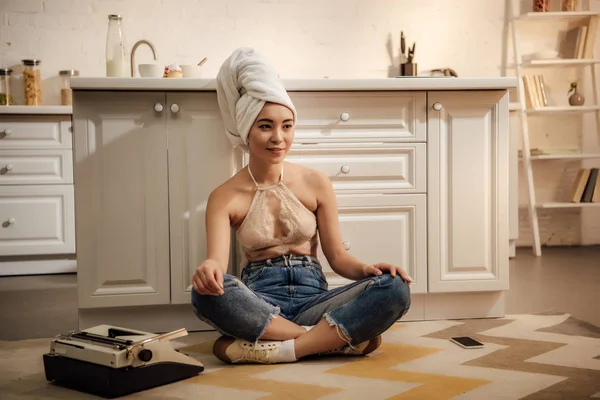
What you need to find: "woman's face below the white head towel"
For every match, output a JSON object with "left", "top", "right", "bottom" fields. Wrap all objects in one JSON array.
[{"left": 248, "top": 103, "right": 294, "bottom": 164}]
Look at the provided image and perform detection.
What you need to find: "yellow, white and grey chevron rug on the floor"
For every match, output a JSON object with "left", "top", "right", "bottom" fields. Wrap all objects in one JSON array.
[{"left": 0, "top": 314, "right": 600, "bottom": 400}]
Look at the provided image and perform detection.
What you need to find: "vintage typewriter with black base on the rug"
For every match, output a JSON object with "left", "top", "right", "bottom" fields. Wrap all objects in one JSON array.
[{"left": 43, "top": 325, "right": 204, "bottom": 398}]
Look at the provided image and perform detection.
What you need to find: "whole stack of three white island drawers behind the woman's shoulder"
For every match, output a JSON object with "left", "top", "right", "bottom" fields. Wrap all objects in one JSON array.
[{"left": 288, "top": 91, "right": 427, "bottom": 293}]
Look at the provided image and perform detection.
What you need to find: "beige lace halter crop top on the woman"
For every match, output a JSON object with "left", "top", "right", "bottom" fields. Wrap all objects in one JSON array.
[{"left": 236, "top": 166, "right": 318, "bottom": 261}]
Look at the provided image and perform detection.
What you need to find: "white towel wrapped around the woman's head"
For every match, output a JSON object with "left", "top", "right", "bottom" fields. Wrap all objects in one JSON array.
[{"left": 217, "top": 47, "right": 297, "bottom": 151}]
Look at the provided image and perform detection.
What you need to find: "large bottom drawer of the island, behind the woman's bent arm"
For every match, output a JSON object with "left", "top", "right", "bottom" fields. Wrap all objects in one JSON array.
[{"left": 318, "top": 194, "right": 427, "bottom": 293}]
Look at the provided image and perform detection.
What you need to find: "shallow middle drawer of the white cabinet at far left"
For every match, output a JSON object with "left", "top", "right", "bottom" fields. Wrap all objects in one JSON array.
[{"left": 0, "top": 149, "right": 73, "bottom": 185}]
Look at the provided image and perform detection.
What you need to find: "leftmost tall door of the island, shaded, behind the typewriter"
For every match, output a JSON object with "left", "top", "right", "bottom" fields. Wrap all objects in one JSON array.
[{"left": 73, "top": 92, "right": 170, "bottom": 308}]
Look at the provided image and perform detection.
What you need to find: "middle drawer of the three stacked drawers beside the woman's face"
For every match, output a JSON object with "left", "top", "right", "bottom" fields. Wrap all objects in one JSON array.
[{"left": 288, "top": 143, "right": 427, "bottom": 193}]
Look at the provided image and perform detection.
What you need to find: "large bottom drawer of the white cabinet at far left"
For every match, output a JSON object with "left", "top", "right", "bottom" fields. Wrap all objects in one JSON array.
[{"left": 0, "top": 185, "right": 75, "bottom": 256}]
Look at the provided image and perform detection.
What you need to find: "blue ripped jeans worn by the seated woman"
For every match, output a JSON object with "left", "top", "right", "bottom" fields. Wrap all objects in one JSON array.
[{"left": 192, "top": 255, "right": 410, "bottom": 345}]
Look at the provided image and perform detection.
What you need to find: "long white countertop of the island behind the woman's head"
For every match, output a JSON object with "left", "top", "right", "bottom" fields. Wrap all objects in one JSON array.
[{"left": 71, "top": 77, "right": 517, "bottom": 91}]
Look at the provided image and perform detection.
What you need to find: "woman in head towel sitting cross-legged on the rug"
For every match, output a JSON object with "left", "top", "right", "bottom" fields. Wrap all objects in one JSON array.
[{"left": 192, "top": 48, "right": 411, "bottom": 363}]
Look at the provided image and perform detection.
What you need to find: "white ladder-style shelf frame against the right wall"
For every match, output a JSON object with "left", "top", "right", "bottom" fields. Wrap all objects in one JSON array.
[{"left": 509, "top": 1, "right": 600, "bottom": 256}]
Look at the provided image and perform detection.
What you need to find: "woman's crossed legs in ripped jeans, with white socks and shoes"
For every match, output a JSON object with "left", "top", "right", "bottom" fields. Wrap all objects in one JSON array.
[{"left": 192, "top": 260, "right": 410, "bottom": 363}]
